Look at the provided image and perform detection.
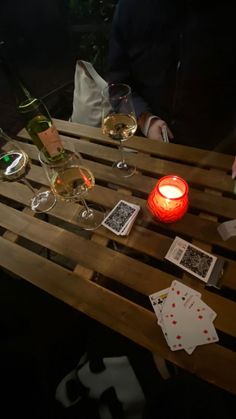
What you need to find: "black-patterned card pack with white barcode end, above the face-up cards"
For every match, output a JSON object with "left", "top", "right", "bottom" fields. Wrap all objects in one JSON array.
[{"left": 165, "top": 237, "right": 217, "bottom": 282}]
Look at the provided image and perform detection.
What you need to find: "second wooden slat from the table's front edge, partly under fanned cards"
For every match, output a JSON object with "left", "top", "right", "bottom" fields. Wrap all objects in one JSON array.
[{"left": 0, "top": 204, "right": 236, "bottom": 342}]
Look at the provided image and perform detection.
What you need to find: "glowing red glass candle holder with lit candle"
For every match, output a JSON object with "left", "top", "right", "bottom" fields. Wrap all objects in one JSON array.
[{"left": 147, "top": 175, "right": 188, "bottom": 223}]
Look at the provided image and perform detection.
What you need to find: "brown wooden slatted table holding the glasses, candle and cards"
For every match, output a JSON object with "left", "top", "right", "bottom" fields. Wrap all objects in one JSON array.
[{"left": 0, "top": 120, "right": 236, "bottom": 394}]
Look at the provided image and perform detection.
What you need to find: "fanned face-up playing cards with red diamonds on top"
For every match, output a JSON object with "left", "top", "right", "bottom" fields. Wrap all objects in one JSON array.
[{"left": 149, "top": 280, "right": 219, "bottom": 354}]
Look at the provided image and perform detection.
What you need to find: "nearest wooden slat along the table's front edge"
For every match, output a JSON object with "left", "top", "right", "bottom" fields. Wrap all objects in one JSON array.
[{"left": 0, "top": 237, "right": 236, "bottom": 393}]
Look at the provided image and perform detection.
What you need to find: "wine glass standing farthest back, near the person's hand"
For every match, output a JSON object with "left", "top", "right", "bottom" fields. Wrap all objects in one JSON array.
[{"left": 102, "top": 83, "right": 137, "bottom": 177}]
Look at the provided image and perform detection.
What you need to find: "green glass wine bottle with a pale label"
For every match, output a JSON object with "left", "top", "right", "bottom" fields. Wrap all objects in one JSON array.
[{"left": 1, "top": 48, "right": 65, "bottom": 161}]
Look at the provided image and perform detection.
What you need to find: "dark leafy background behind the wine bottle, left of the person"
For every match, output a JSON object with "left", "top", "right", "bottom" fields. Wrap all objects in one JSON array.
[{"left": 0, "top": 0, "right": 116, "bottom": 135}]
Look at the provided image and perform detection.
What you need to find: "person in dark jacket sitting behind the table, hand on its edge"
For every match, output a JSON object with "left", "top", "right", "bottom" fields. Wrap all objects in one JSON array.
[{"left": 108, "top": 0, "right": 236, "bottom": 154}]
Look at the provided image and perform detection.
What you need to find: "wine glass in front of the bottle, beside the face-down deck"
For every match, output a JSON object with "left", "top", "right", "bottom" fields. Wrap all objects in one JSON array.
[{"left": 39, "top": 149, "right": 105, "bottom": 230}]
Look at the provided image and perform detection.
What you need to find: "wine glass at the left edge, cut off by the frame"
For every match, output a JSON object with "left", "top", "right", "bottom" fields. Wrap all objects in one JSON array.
[{"left": 0, "top": 128, "right": 56, "bottom": 212}]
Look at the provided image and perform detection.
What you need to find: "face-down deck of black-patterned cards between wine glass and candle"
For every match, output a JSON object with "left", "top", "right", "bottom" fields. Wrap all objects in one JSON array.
[{"left": 102, "top": 200, "right": 139, "bottom": 235}]
